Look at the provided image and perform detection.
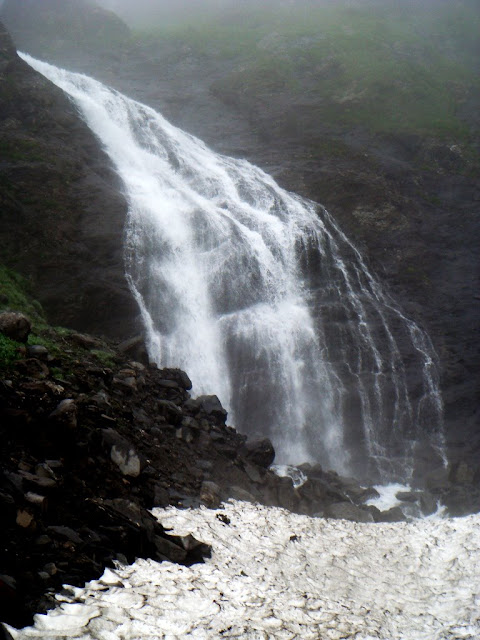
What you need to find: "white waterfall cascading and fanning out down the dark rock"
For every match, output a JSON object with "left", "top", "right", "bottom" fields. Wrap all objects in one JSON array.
[{"left": 23, "top": 55, "right": 443, "bottom": 480}]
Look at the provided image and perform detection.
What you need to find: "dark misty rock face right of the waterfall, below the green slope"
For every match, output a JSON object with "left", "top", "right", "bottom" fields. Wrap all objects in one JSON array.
[{"left": 3, "top": 0, "right": 480, "bottom": 460}]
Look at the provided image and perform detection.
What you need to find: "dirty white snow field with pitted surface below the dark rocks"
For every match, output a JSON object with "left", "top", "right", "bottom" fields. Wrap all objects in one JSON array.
[{"left": 9, "top": 502, "right": 480, "bottom": 640}]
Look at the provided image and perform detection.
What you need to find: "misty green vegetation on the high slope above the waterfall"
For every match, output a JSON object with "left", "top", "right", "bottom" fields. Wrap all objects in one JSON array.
[{"left": 137, "top": 0, "right": 480, "bottom": 140}]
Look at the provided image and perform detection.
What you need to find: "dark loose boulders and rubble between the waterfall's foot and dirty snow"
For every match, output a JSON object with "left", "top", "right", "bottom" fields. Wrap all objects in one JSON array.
[{"left": 0, "top": 302, "right": 480, "bottom": 635}]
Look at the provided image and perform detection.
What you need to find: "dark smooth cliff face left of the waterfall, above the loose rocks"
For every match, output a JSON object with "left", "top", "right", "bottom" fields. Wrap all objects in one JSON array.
[{"left": 0, "top": 18, "right": 136, "bottom": 337}]
